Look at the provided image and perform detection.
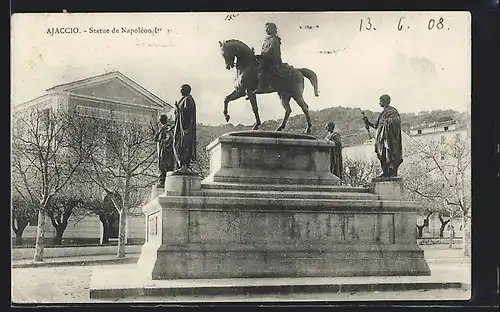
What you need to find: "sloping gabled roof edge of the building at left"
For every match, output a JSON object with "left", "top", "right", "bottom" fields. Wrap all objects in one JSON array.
[{"left": 45, "top": 71, "right": 172, "bottom": 108}]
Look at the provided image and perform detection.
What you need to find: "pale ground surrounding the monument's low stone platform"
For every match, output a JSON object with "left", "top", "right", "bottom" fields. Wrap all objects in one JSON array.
[{"left": 12, "top": 248, "right": 470, "bottom": 303}]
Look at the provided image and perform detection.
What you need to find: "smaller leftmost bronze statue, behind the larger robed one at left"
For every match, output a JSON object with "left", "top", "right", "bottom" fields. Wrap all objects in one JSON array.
[{"left": 154, "top": 114, "right": 174, "bottom": 188}]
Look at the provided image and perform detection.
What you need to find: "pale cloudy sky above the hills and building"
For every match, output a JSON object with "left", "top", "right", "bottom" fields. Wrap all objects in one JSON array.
[{"left": 11, "top": 12, "right": 471, "bottom": 125}]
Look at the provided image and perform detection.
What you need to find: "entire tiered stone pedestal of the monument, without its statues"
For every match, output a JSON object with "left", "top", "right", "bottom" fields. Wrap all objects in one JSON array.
[{"left": 138, "top": 131, "right": 430, "bottom": 280}]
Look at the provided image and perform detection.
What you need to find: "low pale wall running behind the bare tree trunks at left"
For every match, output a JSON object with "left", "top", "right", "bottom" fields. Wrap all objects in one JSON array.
[{"left": 12, "top": 245, "right": 142, "bottom": 260}]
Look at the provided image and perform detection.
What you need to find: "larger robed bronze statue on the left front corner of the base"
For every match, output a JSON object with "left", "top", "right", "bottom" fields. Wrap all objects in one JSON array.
[{"left": 174, "top": 84, "right": 196, "bottom": 171}]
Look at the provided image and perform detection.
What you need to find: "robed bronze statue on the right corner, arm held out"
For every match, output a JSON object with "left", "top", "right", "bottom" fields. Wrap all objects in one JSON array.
[{"left": 363, "top": 94, "right": 403, "bottom": 177}]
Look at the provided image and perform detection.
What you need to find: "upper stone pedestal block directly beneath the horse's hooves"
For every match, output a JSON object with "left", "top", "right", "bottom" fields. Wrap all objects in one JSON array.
[{"left": 205, "top": 131, "right": 340, "bottom": 185}]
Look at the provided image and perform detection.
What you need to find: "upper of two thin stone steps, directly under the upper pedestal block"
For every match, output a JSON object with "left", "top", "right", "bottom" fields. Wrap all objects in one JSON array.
[{"left": 201, "top": 182, "right": 370, "bottom": 193}]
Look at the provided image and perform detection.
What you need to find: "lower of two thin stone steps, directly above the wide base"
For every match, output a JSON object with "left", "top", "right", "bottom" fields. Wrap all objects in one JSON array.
[{"left": 200, "top": 189, "right": 381, "bottom": 200}]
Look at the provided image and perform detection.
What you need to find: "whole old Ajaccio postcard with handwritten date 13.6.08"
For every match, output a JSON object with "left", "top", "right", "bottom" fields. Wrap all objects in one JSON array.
[{"left": 11, "top": 11, "right": 472, "bottom": 304}]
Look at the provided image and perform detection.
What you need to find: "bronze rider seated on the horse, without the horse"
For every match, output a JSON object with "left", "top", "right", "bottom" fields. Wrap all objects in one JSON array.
[{"left": 253, "top": 23, "right": 283, "bottom": 94}]
